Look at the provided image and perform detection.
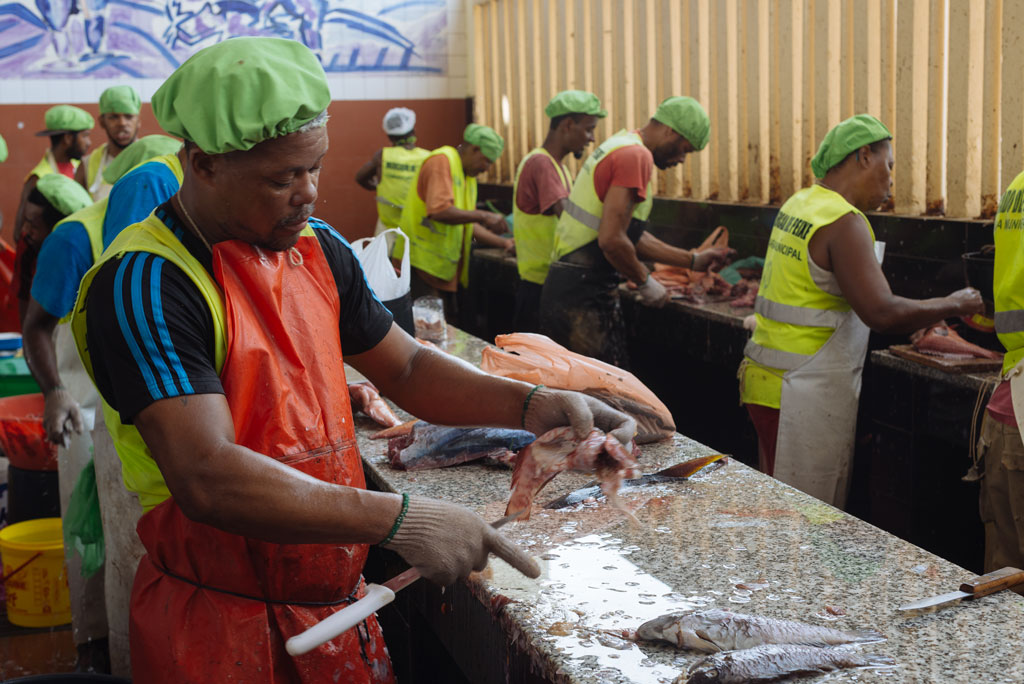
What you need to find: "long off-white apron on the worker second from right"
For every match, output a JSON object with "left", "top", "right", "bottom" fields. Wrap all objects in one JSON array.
[{"left": 774, "top": 242, "right": 885, "bottom": 508}]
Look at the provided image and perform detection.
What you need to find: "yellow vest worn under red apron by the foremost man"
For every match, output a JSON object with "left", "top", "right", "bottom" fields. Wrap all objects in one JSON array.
[{"left": 71, "top": 214, "right": 314, "bottom": 511}]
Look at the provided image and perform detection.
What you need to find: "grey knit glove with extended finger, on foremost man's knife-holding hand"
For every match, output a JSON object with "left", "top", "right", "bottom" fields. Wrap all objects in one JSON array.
[{"left": 387, "top": 497, "right": 541, "bottom": 586}]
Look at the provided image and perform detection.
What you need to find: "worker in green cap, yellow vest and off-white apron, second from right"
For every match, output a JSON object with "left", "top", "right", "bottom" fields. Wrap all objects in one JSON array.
[{"left": 738, "top": 114, "right": 983, "bottom": 508}]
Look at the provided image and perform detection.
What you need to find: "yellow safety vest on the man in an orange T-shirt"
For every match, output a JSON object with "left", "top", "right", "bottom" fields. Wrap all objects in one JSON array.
[{"left": 399, "top": 145, "right": 476, "bottom": 288}]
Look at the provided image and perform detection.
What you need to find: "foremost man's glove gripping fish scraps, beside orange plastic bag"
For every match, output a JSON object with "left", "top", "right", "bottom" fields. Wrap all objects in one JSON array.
[{"left": 522, "top": 386, "right": 637, "bottom": 445}]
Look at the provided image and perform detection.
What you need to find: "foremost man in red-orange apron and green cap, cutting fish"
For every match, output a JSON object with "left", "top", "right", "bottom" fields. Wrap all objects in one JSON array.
[{"left": 72, "top": 38, "right": 635, "bottom": 684}]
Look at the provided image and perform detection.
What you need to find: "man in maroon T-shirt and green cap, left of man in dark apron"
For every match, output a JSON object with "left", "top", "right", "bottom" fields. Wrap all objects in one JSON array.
[{"left": 512, "top": 90, "right": 608, "bottom": 333}]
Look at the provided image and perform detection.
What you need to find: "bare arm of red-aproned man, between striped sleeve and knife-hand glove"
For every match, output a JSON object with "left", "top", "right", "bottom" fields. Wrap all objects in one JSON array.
[{"left": 135, "top": 394, "right": 401, "bottom": 544}]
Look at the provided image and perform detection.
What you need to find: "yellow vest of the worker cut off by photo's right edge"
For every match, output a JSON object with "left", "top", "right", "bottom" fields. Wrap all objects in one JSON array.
[{"left": 992, "top": 173, "right": 1024, "bottom": 373}]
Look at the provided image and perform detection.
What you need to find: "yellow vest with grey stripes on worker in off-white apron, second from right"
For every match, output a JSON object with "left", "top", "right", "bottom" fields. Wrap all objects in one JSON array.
[{"left": 739, "top": 184, "right": 874, "bottom": 409}]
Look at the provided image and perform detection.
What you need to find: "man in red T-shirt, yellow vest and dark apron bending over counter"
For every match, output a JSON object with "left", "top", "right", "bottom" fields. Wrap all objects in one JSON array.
[{"left": 541, "top": 97, "right": 727, "bottom": 368}]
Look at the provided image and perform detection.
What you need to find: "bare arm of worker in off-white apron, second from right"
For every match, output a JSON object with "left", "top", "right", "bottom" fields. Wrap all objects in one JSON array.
[{"left": 809, "top": 213, "right": 982, "bottom": 334}]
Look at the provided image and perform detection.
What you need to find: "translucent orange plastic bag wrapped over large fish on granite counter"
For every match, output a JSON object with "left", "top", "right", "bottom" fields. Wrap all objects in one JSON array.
[{"left": 480, "top": 333, "right": 676, "bottom": 443}]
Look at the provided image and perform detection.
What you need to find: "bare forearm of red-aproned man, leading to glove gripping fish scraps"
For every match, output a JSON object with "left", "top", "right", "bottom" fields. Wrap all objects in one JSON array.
[{"left": 345, "top": 325, "right": 530, "bottom": 428}]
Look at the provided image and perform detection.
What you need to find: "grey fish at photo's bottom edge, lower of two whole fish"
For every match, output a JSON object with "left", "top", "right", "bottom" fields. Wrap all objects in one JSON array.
[{"left": 673, "top": 644, "right": 896, "bottom": 684}]
